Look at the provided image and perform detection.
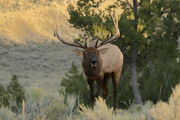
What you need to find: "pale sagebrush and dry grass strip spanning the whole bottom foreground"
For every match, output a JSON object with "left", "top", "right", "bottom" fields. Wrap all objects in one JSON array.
[{"left": 0, "top": 84, "right": 180, "bottom": 120}]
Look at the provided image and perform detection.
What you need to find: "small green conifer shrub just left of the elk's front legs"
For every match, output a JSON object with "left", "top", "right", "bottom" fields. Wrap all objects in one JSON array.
[{"left": 59, "top": 63, "right": 90, "bottom": 104}]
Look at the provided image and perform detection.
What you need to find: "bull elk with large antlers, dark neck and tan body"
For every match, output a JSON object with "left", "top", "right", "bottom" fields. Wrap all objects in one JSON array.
[{"left": 54, "top": 19, "right": 123, "bottom": 109}]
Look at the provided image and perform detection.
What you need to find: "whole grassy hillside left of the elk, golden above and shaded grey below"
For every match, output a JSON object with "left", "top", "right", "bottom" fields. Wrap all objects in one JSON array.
[{"left": 0, "top": 0, "right": 79, "bottom": 92}]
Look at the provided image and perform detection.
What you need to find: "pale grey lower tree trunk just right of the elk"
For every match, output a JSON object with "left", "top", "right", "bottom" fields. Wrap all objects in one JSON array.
[{"left": 131, "top": 47, "right": 143, "bottom": 104}]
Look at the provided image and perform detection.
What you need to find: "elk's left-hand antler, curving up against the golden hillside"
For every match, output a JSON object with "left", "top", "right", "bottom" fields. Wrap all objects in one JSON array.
[{"left": 54, "top": 11, "right": 86, "bottom": 49}]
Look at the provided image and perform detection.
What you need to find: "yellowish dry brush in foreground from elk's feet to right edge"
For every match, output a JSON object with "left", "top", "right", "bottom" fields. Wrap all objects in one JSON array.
[{"left": 78, "top": 84, "right": 180, "bottom": 120}]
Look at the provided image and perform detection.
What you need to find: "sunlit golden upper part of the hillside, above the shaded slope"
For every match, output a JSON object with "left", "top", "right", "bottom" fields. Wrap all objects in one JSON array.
[{"left": 0, "top": 0, "right": 78, "bottom": 44}]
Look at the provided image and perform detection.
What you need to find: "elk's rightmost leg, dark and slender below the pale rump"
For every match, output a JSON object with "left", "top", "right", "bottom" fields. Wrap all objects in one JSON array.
[{"left": 112, "top": 72, "right": 120, "bottom": 110}]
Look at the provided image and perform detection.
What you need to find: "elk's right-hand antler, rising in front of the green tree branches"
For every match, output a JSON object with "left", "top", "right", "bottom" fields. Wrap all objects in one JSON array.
[{"left": 95, "top": 17, "right": 120, "bottom": 48}]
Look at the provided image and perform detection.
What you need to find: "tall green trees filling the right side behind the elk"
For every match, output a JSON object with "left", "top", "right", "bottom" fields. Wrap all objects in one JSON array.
[{"left": 68, "top": 0, "right": 180, "bottom": 107}]
